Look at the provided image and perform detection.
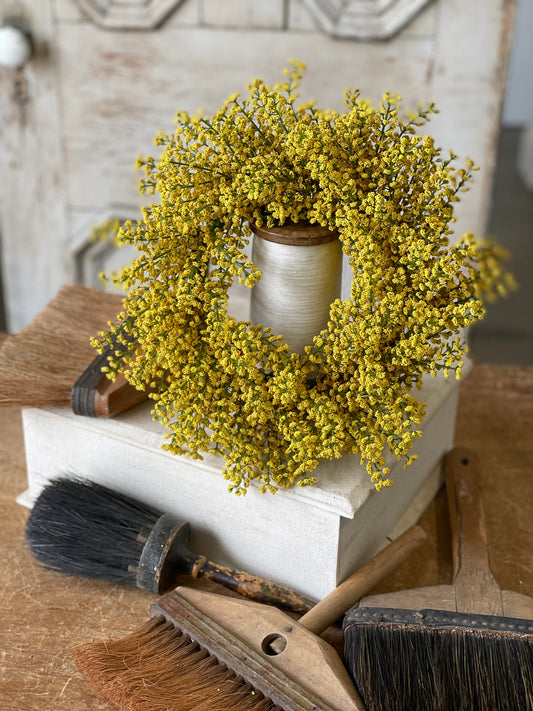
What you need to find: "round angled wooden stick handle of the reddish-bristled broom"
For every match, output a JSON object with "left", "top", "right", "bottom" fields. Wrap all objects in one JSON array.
[{"left": 298, "top": 526, "right": 427, "bottom": 635}]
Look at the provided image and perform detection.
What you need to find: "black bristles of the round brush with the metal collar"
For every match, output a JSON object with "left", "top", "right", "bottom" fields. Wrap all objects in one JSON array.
[{"left": 26, "top": 476, "right": 161, "bottom": 585}]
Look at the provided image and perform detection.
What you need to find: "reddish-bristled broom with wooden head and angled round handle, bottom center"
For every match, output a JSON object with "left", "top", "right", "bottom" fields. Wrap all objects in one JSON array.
[{"left": 76, "top": 526, "right": 426, "bottom": 711}]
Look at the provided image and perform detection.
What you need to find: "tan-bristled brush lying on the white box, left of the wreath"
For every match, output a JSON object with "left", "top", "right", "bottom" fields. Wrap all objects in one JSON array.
[{"left": 0, "top": 285, "right": 148, "bottom": 417}]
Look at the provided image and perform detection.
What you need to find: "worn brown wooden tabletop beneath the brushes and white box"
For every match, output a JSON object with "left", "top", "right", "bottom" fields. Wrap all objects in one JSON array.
[{"left": 0, "top": 365, "right": 533, "bottom": 711}]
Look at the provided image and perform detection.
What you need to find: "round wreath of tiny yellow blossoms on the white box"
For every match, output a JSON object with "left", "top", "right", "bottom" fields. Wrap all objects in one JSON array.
[{"left": 95, "top": 63, "right": 507, "bottom": 494}]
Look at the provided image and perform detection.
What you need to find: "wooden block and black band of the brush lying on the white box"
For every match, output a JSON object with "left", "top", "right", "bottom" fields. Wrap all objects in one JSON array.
[{"left": 71, "top": 349, "right": 150, "bottom": 417}]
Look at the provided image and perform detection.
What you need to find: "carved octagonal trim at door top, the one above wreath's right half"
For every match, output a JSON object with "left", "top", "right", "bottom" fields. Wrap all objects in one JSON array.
[{"left": 303, "top": 0, "right": 431, "bottom": 40}]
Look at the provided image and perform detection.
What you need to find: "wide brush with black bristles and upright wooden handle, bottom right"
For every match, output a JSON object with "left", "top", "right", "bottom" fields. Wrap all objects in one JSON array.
[{"left": 343, "top": 448, "right": 533, "bottom": 711}]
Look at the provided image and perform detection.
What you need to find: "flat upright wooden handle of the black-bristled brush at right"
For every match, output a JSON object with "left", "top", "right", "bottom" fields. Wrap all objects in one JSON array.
[{"left": 444, "top": 447, "right": 503, "bottom": 615}]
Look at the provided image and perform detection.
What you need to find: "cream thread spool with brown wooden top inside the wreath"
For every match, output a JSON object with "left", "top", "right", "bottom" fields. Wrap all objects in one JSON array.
[{"left": 250, "top": 222, "right": 342, "bottom": 354}]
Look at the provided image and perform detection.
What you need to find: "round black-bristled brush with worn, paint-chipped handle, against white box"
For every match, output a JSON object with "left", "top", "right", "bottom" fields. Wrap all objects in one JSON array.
[{"left": 26, "top": 476, "right": 314, "bottom": 613}]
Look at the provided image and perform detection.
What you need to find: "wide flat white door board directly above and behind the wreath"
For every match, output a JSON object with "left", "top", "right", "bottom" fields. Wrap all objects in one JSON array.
[{"left": 59, "top": 24, "right": 432, "bottom": 207}]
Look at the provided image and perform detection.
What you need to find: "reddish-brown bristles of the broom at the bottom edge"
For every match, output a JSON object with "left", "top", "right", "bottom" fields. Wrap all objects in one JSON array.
[{"left": 75, "top": 615, "right": 278, "bottom": 711}]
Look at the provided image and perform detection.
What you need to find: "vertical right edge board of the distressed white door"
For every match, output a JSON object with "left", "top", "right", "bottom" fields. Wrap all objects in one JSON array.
[{"left": 427, "top": 0, "right": 514, "bottom": 241}]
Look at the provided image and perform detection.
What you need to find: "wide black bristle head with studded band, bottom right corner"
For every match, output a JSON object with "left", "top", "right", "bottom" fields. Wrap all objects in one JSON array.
[{"left": 343, "top": 607, "right": 533, "bottom": 711}]
